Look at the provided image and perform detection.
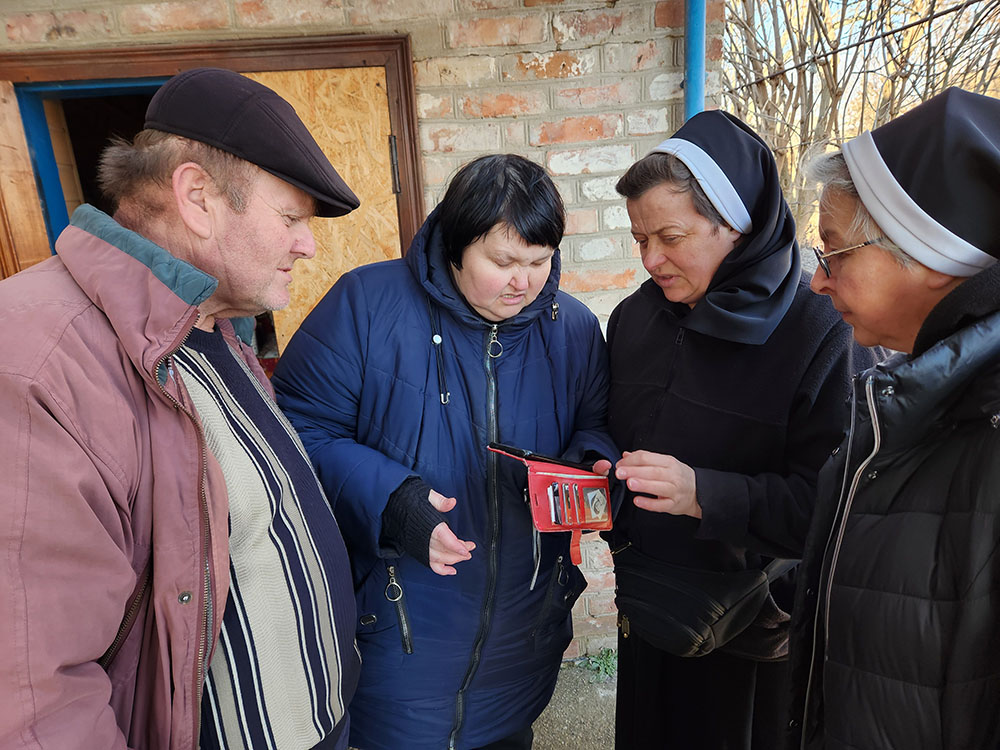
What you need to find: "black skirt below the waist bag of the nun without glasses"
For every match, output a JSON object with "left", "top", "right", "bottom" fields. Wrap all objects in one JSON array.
[{"left": 615, "top": 631, "right": 788, "bottom": 750}]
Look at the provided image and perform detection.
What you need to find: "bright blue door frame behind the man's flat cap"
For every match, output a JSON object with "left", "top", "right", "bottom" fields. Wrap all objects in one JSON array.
[{"left": 14, "top": 76, "right": 167, "bottom": 252}]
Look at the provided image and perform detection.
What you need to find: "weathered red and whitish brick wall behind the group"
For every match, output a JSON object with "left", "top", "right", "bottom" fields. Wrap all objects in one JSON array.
[{"left": 0, "top": 0, "right": 723, "bottom": 656}]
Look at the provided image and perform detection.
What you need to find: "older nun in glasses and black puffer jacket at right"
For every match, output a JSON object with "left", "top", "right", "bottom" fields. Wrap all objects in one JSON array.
[{"left": 788, "top": 89, "right": 1000, "bottom": 750}]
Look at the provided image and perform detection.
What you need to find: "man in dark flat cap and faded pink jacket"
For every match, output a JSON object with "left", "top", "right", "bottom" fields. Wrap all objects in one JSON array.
[{"left": 0, "top": 68, "right": 360, "bottom": 750}]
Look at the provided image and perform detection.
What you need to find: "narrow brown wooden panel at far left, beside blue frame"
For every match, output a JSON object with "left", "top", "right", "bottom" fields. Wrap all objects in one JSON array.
[{"left": 0, "top": 81, "right": 52, "bottom": 278}]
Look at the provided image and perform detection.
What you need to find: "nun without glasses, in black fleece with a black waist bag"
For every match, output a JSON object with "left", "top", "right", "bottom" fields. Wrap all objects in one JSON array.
[{"left": 608, "top": 111, "right": 873, "bottom": 750}]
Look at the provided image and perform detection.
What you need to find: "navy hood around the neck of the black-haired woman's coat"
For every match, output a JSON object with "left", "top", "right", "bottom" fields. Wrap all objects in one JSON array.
[{"left": 406, "top": 208, "right": 561, "bottom": 330}]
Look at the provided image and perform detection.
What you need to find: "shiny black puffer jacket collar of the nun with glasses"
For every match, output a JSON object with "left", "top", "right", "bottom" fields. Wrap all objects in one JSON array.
[{"left": 855, "top": 304, "right": 1000, "bottom": 456}]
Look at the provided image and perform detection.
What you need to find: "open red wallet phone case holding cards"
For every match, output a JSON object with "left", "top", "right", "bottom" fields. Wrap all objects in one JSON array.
[{"left": 486, "top": 443, "right": 611, "bottom": 565}]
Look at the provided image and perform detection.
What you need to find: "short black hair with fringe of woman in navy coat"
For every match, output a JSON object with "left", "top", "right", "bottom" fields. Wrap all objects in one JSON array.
[{"left": 438, "top": 154, "right": 566, "bottom": 268}]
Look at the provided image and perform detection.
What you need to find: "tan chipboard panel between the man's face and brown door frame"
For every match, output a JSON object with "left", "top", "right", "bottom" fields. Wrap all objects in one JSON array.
[{"left": 247, "top": 67, "right": 399, "bottom": 352}]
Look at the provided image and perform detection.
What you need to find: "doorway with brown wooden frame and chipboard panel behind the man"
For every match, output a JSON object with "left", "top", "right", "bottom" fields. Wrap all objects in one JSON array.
[{"left": 0, "top": 36, "right": 424, "bottom": 358}]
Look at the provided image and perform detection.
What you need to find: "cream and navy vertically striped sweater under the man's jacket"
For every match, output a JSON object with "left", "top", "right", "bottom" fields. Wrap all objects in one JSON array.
[{"left": 174, "top": 329, "right": 360, "bottom": 750}]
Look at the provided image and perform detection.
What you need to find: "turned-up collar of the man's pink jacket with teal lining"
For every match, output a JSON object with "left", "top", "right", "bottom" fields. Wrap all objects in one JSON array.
[{"left": 56, "top": 204, "right": 225, "bottom": 385}]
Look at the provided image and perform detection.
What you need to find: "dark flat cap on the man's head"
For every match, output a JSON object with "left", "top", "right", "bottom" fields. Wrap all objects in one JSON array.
[{"left": 145, "top": 68, "right": 361, "bottom": 216}]
